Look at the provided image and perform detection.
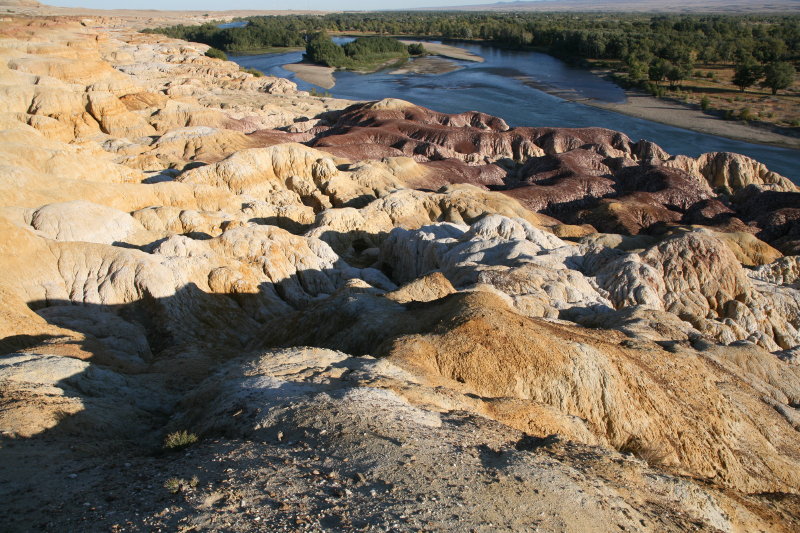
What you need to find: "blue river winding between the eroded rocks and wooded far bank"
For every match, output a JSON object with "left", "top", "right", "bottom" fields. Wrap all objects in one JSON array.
[{"left": 230, "top": 39, "right": 800, "bottom": 183}]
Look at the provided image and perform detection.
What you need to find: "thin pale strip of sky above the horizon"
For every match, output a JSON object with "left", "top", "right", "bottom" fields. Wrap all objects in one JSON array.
[{"left": 45, "top": 0, "right": 497, "bottom": 11}]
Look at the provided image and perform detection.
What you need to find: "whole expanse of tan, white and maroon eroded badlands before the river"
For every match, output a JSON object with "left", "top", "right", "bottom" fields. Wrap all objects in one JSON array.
[{"left": 0, "top": 19, "right": 800, "bottom": 531}]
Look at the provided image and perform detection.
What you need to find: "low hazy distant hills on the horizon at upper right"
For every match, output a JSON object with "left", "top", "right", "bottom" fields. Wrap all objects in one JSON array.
[{"left": 424, "top": 0, "right": 800, "bottom": 13}]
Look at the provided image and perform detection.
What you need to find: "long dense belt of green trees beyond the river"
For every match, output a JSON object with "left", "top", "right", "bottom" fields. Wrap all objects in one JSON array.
[{"left": 149, "top": 12, "right": 800, "bottom": 90}]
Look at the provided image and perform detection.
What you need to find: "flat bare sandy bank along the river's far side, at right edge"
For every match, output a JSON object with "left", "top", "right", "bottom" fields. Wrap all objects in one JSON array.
[{"left": 580, "top": 90, "right": 800, "bottom": 149}]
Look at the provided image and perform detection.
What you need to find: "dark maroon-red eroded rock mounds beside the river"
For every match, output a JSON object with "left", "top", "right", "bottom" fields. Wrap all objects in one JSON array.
[{"left": 310, "top": 100, "right": 800, "bottom": 241}]
